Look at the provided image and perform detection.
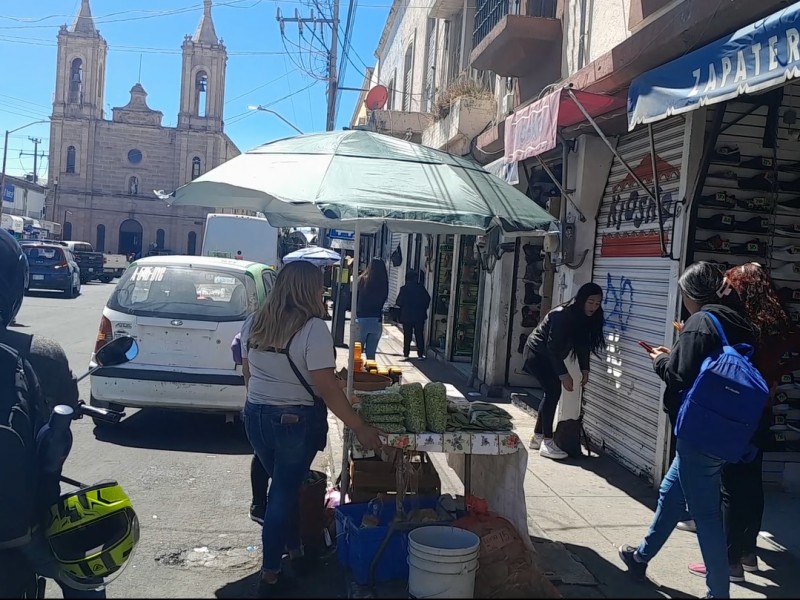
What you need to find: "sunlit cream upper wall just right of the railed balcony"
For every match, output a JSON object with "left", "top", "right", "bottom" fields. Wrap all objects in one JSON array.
[{"left": 562, "top": 0, "right": 631, "bottom": 77}]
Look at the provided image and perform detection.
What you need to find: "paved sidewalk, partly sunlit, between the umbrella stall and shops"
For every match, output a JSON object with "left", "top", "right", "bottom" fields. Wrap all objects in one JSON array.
[{"left": 331, "top": 325, "right": 800, "bottom": 598}]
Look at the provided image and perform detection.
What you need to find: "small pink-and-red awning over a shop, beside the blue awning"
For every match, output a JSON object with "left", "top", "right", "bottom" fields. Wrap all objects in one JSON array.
[{"left": 503, "top": 88, "right": 625, "bottom": 163}]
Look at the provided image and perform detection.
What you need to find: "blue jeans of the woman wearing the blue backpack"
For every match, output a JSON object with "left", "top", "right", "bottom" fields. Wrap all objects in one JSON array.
[{"left": 638, "top": 439, "right": 730, "bottom": 598}]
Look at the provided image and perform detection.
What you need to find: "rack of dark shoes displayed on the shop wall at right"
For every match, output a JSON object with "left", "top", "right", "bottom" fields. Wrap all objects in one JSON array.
[{"left": 689, "top": 97, "right": 800, "bottom": 483}]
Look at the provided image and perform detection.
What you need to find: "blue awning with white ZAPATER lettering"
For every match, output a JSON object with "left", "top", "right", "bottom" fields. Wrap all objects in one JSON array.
[{"left": 628, "top": 3, "right": 800, "bottom": 129}]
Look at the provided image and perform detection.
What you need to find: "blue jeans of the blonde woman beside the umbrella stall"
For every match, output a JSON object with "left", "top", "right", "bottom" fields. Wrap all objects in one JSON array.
[{"left": 244, "top": 402, "right": 328, "bottom": 572}]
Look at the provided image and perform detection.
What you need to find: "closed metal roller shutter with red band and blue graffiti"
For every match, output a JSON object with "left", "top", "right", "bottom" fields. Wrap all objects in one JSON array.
[{"left": 584, "top": 117, "right": 685, "bottom": 481}]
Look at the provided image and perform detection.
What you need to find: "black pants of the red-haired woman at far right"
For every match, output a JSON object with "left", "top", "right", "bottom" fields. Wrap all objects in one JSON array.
[{"left": 722, "top": 452, "right": 764, "bottom": 564}]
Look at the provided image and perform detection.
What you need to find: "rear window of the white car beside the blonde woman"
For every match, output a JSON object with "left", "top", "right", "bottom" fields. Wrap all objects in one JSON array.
[{"left": 108, "top": 265, "right": 257, "bottom": 321}]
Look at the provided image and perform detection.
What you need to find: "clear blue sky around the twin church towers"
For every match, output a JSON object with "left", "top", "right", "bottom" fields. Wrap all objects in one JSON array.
[{"left": 0, "top": 0, "right": 391, "bottom": 177}]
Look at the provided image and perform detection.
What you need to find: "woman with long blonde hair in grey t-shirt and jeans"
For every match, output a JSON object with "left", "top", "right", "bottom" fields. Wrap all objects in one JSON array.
[{"left": 241, "top": 261, "right": 381, "bottom": 597}]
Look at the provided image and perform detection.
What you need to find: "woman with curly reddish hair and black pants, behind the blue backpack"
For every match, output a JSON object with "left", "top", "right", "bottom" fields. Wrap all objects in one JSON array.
[{"left": 689, "top": 263, "right": 800, "bottom": 582}]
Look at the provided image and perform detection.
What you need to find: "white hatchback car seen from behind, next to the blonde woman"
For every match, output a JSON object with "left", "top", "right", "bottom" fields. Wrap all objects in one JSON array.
[{"left": 90, "top": 256, "right": 277, "bottom": 424}]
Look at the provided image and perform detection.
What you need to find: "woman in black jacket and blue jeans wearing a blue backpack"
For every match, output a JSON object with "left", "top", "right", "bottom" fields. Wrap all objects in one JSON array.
[{"left": 619, "top": 262, "right": 756, "bottom": 598}]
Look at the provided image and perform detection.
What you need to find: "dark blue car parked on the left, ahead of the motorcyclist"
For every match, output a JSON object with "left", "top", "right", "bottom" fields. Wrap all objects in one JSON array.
[{"left": 22, "top": 242, "right": 81, "bottom": 298}]
